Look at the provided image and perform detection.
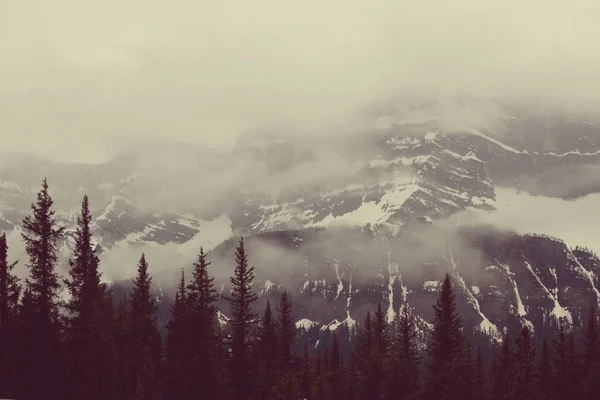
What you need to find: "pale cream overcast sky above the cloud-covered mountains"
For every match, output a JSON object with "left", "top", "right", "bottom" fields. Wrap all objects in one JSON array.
[{"left": 0, "top": 0, "right": 600, "bottom": 162}]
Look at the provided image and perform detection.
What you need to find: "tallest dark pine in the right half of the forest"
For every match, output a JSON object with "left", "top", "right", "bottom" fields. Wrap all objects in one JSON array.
[{"left": 426, "top": 274, "right": 462, "bottom": 400}]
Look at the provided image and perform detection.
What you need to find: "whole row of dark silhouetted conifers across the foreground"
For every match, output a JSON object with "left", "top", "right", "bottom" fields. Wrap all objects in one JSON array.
[{"left": 0, "top": 180, "right": 600, "bottom": 400}]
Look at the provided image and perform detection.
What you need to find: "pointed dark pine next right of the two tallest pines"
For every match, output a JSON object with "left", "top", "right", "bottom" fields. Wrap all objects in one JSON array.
[{"left": 130, "top": 254, "right": 161, "bottom": 394}]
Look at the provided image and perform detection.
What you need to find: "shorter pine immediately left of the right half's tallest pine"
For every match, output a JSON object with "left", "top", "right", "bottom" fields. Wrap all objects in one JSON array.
[{"left": 387, "top": 303, "right": 420, "bottom": 399}]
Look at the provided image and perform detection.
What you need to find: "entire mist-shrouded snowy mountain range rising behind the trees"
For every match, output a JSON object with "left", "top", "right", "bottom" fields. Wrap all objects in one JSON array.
[{"left": 0, "top": 98, "right": 600, "bottom": 346}]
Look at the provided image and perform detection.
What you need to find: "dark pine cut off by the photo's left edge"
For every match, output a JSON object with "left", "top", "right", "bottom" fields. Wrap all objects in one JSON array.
[{"left": 0, "top": 234, "right": 21, "bottom": 397}]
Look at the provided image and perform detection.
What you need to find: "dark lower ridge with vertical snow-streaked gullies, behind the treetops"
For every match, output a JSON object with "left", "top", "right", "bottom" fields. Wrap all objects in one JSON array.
[{"left": 203, "top": 225, "right": 600, "bottom": 352}]
